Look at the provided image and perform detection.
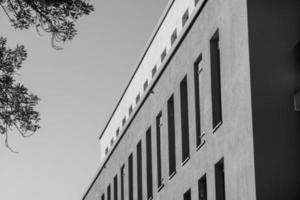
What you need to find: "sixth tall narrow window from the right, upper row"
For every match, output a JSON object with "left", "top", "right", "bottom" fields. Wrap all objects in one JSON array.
[{"left": 146, "top": 127, "right": 153, "bottom": 199}]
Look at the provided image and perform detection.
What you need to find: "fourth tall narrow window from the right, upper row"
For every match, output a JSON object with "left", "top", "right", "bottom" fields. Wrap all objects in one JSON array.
[{"left": 168, "top": 95, "right": 176, "bottom": 177}]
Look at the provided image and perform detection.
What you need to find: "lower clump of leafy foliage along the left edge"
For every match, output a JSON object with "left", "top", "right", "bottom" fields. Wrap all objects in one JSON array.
[{"left": 0, "top": 37, "right": 40, "bottom": 151}]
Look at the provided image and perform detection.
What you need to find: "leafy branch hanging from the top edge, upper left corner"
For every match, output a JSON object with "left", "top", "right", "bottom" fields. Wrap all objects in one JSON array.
[{"left": 0, "top": 0, "right": 94, "bottom": 49}]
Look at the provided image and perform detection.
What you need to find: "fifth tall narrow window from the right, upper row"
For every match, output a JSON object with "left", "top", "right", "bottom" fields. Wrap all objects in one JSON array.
[{"left": 156, "top": 112, "right": 162, "bottom": 188}]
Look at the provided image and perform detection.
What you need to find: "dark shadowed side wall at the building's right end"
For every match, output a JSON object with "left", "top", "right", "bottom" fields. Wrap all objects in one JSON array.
[{"left": 248, "top": 0, "right": 300, "bottom": 200}]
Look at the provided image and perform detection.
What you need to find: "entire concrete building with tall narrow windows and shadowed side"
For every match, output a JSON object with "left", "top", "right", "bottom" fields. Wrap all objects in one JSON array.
[{"left": 83, "top": 0, "right": 300, "bottom": 200}]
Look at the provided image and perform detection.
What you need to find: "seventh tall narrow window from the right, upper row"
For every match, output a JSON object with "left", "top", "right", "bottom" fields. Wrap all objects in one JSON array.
[{"left": 136, "top": 141, "right": 143, "bottom": 200}]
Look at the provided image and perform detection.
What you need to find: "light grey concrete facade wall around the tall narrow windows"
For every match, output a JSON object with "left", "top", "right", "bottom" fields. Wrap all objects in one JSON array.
[{"left": 84, "top": 0, "right": 256, "bottom": 200}]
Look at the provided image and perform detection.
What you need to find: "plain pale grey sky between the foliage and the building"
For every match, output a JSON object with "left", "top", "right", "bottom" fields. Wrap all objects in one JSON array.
[{"left": 0, "top": 0, "right": 168, "bottom": 200}]
